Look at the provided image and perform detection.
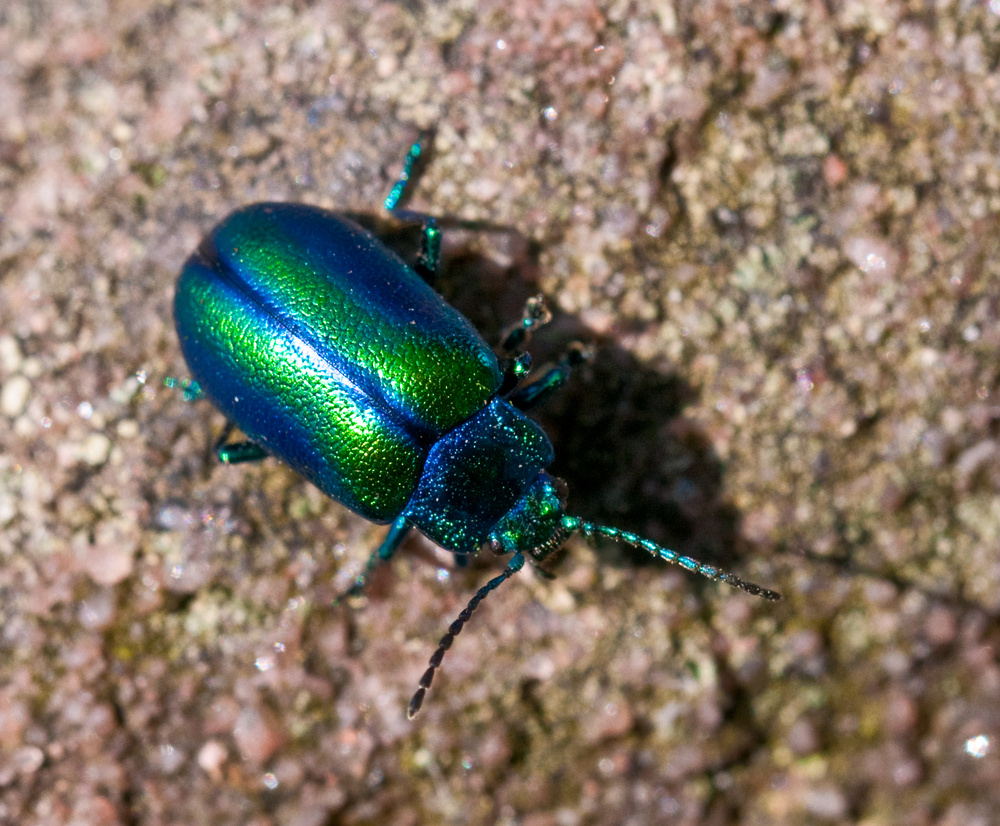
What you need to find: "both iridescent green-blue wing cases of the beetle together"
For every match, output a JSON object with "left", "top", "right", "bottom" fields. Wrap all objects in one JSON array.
[{"left": 174, "top": 204, "right": 502, "bottom": 522}]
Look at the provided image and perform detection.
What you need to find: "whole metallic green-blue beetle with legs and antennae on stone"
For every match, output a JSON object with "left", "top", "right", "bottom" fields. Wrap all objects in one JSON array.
[{"left": 174, "top": 137, "right": 779, "bottom": 719}]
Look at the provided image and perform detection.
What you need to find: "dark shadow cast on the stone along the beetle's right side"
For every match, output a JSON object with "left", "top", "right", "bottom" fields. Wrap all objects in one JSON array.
[{"left": 360, "top": 222, "right": 744, "bottom": 573}]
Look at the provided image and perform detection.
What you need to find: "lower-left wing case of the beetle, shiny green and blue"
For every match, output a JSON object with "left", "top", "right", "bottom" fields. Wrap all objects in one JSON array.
[{"left": 175, "top": 254, "right": 425, "bottom": 522}]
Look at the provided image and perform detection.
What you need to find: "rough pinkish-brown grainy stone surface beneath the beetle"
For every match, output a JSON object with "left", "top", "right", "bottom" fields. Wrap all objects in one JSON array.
[{"left": 0, "top": 0, "right": 1000, "bottom": 826}]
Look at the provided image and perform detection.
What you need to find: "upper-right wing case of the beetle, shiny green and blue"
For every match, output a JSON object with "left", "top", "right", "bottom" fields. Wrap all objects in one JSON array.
[{"left": 213, "top": 204, "right": 501, "bottom": 435}]
